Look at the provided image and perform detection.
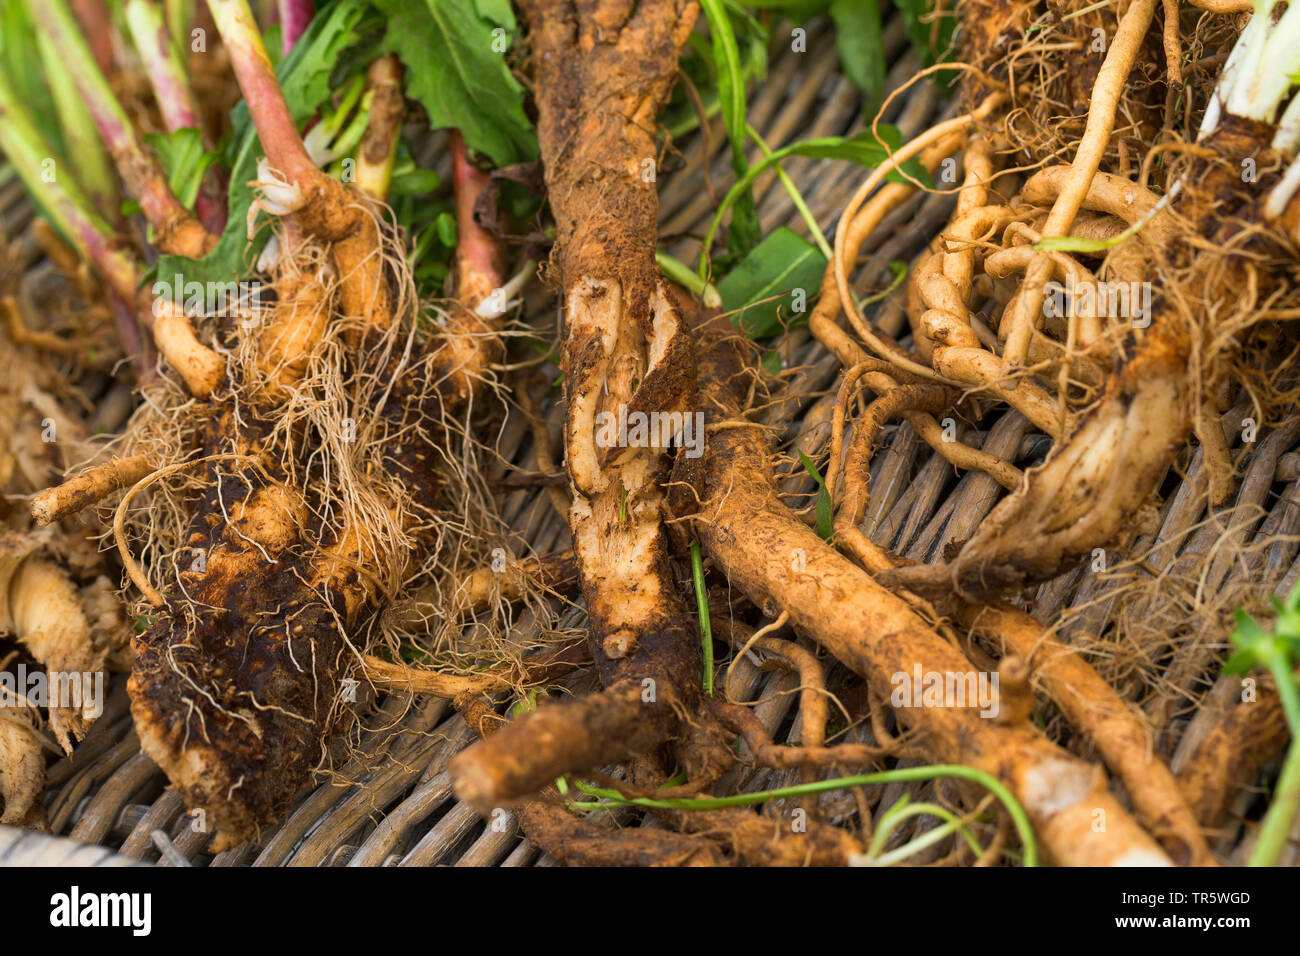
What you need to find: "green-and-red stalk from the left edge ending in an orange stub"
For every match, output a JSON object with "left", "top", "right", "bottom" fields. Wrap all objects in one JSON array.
[{"left": 0, "top": 68, "right": 225, "bottom": 398}]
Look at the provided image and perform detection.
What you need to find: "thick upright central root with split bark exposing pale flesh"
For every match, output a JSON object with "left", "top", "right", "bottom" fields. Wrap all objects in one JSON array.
[{"left": 449, "top": 0, "right": 731, "bottom": 813}]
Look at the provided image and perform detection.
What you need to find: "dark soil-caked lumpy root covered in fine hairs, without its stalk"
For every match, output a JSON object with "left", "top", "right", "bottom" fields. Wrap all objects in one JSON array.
[{"left": 119, "top": 243, "right": 506, "bottom": 847}]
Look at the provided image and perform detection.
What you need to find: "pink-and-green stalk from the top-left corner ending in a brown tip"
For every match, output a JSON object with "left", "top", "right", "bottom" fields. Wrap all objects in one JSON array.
[{"left": 29, "top": 0, "right": 216, "bottom": 259}]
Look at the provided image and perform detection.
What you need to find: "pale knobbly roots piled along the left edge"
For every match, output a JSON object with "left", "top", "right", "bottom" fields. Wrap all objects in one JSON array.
[{"left": 0, "top": 228, "right": 130, "bottom": 829}]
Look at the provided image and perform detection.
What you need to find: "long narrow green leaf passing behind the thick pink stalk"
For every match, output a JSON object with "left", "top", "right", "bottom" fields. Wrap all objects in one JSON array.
[{"left": 159, "top": 0, "right": 377, "bottom": 282}]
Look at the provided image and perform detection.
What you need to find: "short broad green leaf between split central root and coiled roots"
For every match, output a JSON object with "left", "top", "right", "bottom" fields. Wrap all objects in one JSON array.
[{"left": 718, "top": 226, "right": 826, "bottom": 338}]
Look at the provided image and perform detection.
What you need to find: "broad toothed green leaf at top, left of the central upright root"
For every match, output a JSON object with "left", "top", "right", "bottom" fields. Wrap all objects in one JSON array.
[{"left": 374, "top": 0, "right": 537, "bottom": 165}]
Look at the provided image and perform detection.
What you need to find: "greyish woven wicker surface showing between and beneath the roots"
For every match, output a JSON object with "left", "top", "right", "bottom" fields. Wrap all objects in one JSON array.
[{"left": 10, "top": 20, "right": 1300, "bottom": 866}]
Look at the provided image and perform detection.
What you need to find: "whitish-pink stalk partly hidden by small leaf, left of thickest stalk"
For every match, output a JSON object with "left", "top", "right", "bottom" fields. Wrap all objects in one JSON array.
[{"left": 125, "top": 0, "right": 226, "bottom": 235}]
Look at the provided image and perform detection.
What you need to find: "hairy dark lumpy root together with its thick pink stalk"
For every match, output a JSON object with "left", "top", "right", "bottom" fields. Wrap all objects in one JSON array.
[{"left": 47, "top": 11, "right": 517, "bottom": 849}]
